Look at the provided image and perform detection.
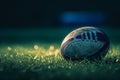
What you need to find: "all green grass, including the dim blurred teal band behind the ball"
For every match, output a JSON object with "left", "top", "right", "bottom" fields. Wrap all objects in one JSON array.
[{"left": 0, "top": 28, "right": 120, "bottom": 80}]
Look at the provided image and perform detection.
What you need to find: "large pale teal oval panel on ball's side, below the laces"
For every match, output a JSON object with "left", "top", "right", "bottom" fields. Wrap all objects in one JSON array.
[{"left": 63, "top": 40, "right": 103, "bottom": 58}]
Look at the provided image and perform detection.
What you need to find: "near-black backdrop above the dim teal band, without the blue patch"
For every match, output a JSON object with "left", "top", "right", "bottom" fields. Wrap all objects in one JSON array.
[{"left": 0, "top": 0, "right": 120, "bottom": 28}]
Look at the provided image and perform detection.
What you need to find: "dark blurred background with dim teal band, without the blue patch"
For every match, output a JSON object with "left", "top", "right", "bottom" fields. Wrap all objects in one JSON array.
[{"left": 0, "top": 0, "right": 120, "bottom": 43}]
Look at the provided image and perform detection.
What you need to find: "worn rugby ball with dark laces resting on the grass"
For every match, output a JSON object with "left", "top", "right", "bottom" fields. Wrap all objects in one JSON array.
[{"left": 60, "top": 26, "right": 110, "bottom": 60}]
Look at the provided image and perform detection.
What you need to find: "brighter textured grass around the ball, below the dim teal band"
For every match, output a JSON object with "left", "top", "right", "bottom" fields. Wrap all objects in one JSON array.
[{"left": 0, "top": 27, "right": 120, "bottom": 80}]
